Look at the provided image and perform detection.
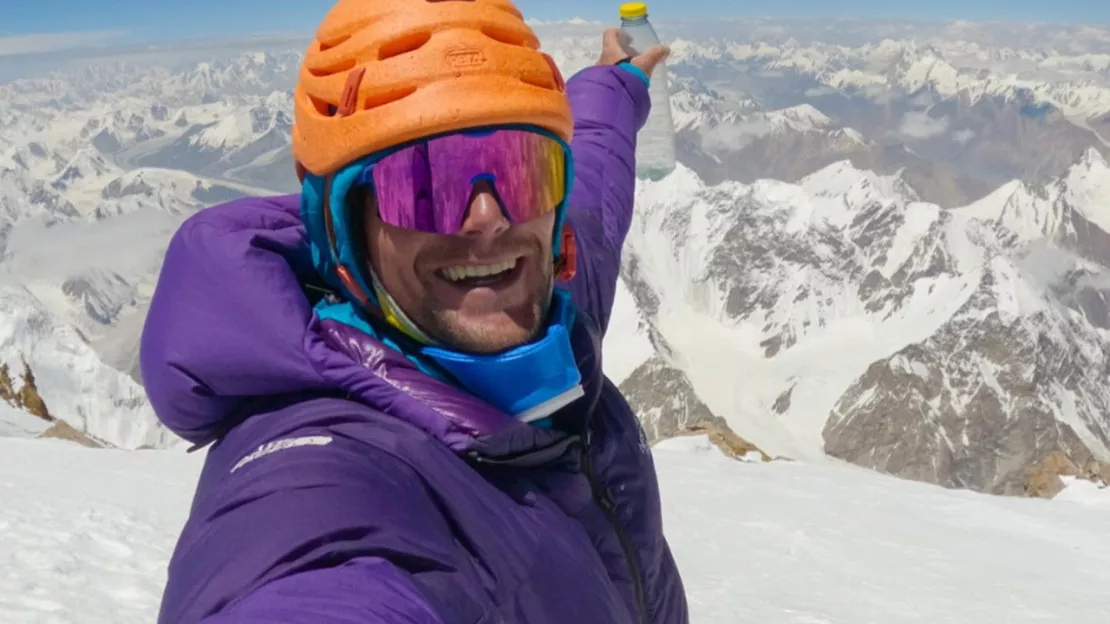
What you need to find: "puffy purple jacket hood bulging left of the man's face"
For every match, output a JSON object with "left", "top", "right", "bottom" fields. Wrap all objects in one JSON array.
[{"left": 140, "top": 195, "right": 331, "bottom": 443}]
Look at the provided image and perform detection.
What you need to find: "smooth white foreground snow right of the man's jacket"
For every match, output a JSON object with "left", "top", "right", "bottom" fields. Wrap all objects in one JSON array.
[{"left": 655, "top": 439, "right": 1110, "bottom": 624}]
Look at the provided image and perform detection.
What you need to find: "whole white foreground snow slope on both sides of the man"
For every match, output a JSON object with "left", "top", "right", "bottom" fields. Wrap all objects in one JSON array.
[{"left": 0, "top": 433, "right": 1110, "bottom": 624}]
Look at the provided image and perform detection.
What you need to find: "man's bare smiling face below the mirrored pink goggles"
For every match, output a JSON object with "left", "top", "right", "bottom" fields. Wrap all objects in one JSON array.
[{"left": 356, "top": 173, "right": 562, "bottom": 353}]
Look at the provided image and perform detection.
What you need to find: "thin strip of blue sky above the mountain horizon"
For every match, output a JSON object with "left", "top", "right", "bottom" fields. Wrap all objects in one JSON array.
[{"left": 0, "top": 0, "right": 1110, "bottom": 56}]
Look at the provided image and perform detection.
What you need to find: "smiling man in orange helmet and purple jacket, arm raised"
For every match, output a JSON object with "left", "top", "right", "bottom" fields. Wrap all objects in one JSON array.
[{"left": 141, "top": 0, "right": 687, "bottom": 624}]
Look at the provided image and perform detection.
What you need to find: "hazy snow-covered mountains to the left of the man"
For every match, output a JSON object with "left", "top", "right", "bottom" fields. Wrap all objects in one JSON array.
[{"left": 0, "top": 53, "right": 299, "bottom": 447}]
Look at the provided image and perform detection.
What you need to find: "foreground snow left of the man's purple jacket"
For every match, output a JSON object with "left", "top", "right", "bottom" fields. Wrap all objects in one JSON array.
[{"left": 0, "top": 437, "right": 202, "bottom": 624}]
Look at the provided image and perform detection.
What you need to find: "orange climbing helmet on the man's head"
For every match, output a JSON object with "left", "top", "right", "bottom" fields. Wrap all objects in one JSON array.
[{"left": 293, "top": 0, "right": 574, "bottom": 178}]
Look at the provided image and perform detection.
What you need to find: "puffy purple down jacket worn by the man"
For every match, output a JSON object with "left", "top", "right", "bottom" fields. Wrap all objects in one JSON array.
[{"left": 141, "top": 67, "right": 688, "bottom": 624}]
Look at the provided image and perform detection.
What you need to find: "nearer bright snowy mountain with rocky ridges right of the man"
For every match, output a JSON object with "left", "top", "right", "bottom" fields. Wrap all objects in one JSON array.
[{"left": 611, "top": 151, "right": 1110, "bottom": 493}]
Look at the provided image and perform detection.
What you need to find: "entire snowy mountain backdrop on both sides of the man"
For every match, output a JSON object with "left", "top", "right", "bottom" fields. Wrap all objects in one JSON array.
[{"left": 0, "top": 20, "right": 1110, "bottom": 493}]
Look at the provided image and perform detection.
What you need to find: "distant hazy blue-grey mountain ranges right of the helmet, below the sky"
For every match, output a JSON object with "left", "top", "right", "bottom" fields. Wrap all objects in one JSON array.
[{"left": 521, "top": 20, "right": 1110, "bottom": 208}]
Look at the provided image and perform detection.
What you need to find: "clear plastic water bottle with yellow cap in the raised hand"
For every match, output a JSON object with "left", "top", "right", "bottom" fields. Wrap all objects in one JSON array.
[{"left": 620, "top": 2, "right": 675, "bottom": 180}]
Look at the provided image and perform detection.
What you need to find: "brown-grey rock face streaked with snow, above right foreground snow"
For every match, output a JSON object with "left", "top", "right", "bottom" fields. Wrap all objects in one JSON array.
[{"left": 825, "top": 326, "right": 1091, "bottom": 494}]
